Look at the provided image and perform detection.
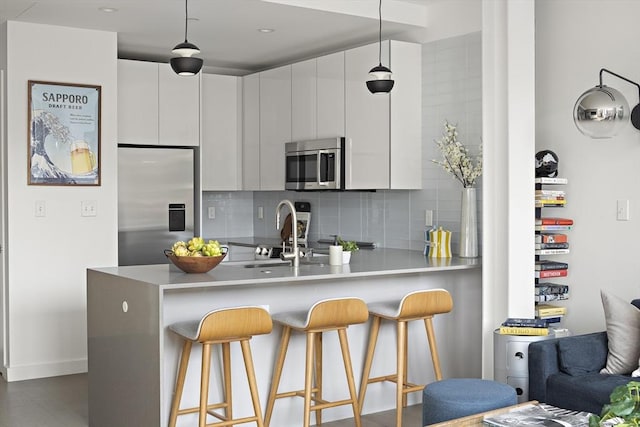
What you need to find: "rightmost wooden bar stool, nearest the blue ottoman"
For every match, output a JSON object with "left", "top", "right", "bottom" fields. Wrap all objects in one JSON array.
[{"left": 358, "top": 289, "right": 453, "bottom": 427}]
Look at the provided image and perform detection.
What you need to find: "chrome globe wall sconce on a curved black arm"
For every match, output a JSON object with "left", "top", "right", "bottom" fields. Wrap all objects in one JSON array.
[{"left": 573, "top": 68, "right": 640, "bottom": 138}]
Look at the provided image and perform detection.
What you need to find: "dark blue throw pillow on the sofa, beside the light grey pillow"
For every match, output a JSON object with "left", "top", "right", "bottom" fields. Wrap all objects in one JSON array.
[{"left": 558, "top": 336, "right": 607, "bottom": 376}]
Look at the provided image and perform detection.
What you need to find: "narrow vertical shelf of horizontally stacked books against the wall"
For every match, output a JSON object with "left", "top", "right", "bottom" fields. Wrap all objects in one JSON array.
[{"left": 534, "top": 177, "right": 573, "bottom": 327}]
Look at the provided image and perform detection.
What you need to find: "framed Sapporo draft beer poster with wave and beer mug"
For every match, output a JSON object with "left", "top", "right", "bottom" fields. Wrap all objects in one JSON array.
[{"left": 27, "top": 80, "right": 101, "bottom": 185}]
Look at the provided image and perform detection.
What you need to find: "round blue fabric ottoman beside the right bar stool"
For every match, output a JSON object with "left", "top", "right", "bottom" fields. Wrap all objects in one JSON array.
[{"left": 422, "top": 378, "right": 518, "bottom": 426}]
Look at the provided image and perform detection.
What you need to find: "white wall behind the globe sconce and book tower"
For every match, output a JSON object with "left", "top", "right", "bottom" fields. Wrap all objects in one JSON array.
[{"left": 536, "top": 0, "right": 640, "bottom": 333}]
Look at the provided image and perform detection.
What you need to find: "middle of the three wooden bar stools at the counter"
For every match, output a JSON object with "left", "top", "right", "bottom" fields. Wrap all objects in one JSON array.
[{"left": 264, "top": 298, "right": 369, "bottom": 427}]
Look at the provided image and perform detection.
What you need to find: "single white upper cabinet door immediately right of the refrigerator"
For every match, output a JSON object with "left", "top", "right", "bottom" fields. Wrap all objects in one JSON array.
[{"left": 200, "top": 74, "right": 242, "bottom": 191}]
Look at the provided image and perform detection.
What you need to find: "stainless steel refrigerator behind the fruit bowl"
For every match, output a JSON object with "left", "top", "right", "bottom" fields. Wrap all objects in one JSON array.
[{"left": 118, "top": 145, "right": 200, "bottom": 265}]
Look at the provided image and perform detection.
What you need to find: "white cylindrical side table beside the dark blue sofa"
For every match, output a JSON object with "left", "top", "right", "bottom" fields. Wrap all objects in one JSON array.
[{"left": 493, "top": 329, "right": 555, "bottom": 403}]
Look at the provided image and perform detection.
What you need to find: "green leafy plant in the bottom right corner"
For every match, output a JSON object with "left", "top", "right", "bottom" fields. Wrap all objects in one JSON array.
[{"left": 589, "top": 381, "right": 640, "bottom": 427}]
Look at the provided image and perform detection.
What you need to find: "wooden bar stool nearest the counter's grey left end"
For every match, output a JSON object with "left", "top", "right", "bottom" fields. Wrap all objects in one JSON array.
[{"left": 169, "top": 307, "right": 273, "bottom": 427}]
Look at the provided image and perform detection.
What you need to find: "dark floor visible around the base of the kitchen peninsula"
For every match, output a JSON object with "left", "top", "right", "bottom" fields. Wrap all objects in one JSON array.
[{"left": 0, "top": 374, "right": 422, "bottom": 427}]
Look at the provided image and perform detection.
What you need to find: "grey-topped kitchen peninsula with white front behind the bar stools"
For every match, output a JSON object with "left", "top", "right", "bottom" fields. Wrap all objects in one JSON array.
[{"left": 87, "top": 249, "right": 482, "bottom": 427}]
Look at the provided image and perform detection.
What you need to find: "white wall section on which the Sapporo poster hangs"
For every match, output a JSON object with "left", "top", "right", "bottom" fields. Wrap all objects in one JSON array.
[{"left": 2, "top": 21, "right": 117, "bottom": 381}]
